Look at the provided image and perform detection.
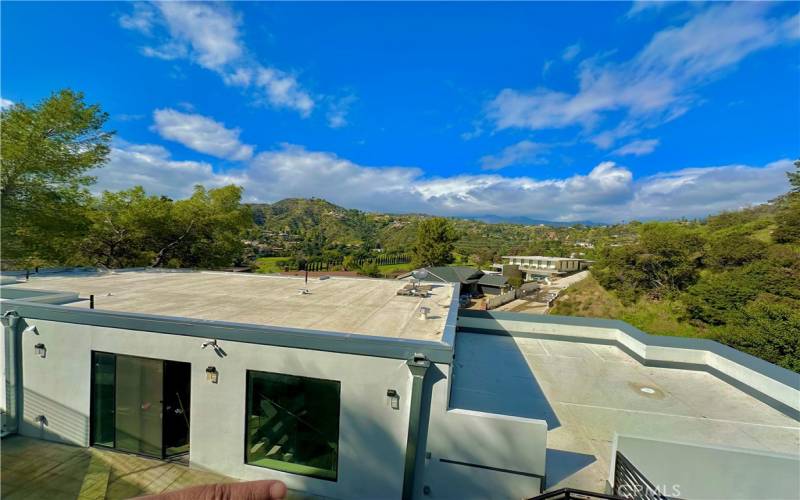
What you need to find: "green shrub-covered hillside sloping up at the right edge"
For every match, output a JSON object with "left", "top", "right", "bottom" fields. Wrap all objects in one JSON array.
[{"left": 551, "top": 193, "right": 800, "bottom": 372}]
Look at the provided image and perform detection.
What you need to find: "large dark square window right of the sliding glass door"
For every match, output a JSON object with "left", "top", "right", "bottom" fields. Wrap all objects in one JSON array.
[{"left": 246, "top": 371, "right": 340, "bottom": 480}]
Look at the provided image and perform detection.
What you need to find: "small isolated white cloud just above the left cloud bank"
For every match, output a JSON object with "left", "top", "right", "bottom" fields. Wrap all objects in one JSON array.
[{"left": 153, "top": 109, "right": 253, "bottom": 161}]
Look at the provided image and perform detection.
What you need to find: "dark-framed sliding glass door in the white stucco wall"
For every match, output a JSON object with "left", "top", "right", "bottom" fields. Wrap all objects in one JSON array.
[{"left": 91, "top": 352, "right": 191, "bottom": 458}]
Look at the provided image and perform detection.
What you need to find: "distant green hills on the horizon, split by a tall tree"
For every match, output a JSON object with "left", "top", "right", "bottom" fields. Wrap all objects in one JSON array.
[{"left": 250, "top": 198, "right": 634, "bottom": 262}]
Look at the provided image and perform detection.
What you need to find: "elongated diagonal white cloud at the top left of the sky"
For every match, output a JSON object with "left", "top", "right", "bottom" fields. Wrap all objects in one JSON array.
[{"left": 119, "top": 2, "right": 314, "bottom": 117}]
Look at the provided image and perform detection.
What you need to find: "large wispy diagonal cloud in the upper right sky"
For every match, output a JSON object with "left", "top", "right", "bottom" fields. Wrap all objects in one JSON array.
[{"left": 487, "top": 2, "right": 798, "bottom": 147}]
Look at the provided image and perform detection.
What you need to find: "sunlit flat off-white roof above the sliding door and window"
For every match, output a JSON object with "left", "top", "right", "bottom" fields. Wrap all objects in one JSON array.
[{"left": 10, "top": 271, "right": 453, "bottom": 340}]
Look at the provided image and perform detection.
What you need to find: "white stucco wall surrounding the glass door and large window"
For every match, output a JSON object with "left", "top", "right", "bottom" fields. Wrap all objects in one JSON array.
[{"left": 20, "top": 320, "right": 411, "bottom": 498}]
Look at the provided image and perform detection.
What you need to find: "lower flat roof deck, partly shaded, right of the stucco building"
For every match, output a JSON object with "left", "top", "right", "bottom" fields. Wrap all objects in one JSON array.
[{"left": 450, "top": 332, "right": 800, "bottom": 491}]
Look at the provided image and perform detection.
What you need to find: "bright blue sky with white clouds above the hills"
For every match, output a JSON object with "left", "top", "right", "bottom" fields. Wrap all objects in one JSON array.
[{"left": 0, "top": 2, "right": 800, "bottom": 221}]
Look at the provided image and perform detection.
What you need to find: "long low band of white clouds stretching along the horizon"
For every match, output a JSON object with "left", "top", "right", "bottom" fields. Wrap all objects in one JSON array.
[{"left": 89, "top": 139, "right": 793, "bottom": 222}]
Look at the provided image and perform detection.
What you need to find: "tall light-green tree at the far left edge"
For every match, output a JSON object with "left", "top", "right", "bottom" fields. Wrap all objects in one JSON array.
[{"left": 0, "top": 90, "right": 113, "bottom": 264}]
